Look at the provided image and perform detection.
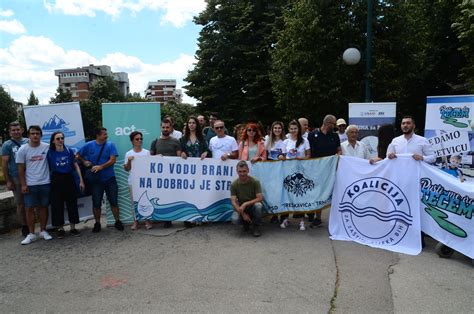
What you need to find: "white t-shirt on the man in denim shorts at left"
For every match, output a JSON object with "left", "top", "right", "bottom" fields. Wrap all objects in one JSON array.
[{"left": 16, "top": 142, "right": 51, "bottom": 186}]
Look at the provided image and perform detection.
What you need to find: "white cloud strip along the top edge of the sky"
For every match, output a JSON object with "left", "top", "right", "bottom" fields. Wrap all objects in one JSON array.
[{"left": 44, "top": 0, "right": 206, "bottom": 27}]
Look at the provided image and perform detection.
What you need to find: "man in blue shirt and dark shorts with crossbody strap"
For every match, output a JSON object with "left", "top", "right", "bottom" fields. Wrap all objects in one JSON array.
[{"left": 76, "top": 127, "right": 123, "bottom": 233}]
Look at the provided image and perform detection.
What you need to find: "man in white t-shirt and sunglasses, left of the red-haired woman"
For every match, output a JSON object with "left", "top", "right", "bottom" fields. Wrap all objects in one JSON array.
[{"left": 209, "top": 120, "right": 239, "bottom": 161}]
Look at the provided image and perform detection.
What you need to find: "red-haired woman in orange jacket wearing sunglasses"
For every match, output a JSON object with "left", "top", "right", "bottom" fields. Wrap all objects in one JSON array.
[{"left": 239, "top": 123, "right": 267, "bottom": 163}]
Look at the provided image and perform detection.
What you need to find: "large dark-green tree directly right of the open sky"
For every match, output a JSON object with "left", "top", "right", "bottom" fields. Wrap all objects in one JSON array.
[{"left": 185, "top": 0, "right": 287, "bottom": 124}]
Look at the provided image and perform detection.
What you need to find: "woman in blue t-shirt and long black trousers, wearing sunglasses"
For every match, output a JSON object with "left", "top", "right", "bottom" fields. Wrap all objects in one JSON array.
[{"left": 47, "top": 132, "right": 85, "bottom": 239}]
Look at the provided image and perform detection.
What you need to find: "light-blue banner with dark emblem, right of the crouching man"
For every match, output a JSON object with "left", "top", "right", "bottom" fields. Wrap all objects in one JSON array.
[{"left": 251, "top": 155, "right": 338, "bottom": 214}]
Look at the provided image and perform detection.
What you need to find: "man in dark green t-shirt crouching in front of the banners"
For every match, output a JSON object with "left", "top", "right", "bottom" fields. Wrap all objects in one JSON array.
[{"left": 230, "top": 160, "right": 263, "bottom": 237}]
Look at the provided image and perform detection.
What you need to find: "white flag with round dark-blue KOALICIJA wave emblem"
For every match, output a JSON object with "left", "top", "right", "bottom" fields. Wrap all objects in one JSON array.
[{"left": 329, "top": 155, "right": 421, "bottom": 255}]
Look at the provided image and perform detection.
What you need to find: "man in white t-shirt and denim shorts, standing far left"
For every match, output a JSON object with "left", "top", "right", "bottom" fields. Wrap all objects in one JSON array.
[{"left": 16, "top": 125, "right": 53, "bottom": 245}]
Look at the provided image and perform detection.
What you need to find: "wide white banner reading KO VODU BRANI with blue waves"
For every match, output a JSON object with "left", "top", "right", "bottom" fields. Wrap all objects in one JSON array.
[{"left": 130, "top": 156, "right": 238, "bottom": 222}]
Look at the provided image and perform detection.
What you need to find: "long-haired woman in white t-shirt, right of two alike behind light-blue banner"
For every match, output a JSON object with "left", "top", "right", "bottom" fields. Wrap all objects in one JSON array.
[{"left": 280, "top": 120, "right": 311, "bottom": 231}]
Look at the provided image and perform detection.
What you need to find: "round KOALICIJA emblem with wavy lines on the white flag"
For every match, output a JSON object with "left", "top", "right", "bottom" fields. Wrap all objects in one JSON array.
[{"left": 339, "top": 177, "right": 413, "bottom": 245}]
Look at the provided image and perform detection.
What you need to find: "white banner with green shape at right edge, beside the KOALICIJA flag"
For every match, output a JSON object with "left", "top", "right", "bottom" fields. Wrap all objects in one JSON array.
[{"left": 420, "top": 163, "right": 474, "bottom": 258}]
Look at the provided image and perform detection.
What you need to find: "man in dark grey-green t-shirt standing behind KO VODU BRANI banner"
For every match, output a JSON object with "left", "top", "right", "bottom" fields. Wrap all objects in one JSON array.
[{"left": 150, "top": 118, "right": 181, "bottom": 228}]
